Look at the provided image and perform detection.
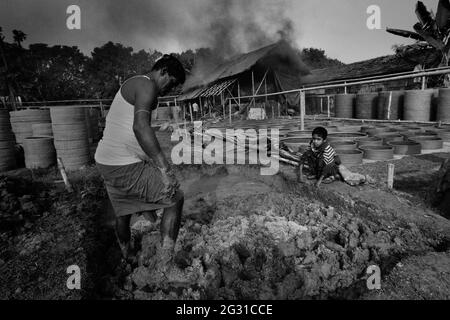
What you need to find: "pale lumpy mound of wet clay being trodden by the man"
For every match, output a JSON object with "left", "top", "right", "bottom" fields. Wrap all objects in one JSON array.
[{"left": 129, "top": 167, "right": 450, "bottom": 299}]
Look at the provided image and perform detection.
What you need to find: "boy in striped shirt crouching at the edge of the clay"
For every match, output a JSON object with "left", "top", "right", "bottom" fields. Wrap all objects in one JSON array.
[{"left": 298, "top": 127, "right": 341, "bottom": 187}]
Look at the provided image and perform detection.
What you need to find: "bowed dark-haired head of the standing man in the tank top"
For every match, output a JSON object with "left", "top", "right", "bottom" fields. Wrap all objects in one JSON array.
[{"left": 152, "top": 54, "right": 186, "bottom": 95}]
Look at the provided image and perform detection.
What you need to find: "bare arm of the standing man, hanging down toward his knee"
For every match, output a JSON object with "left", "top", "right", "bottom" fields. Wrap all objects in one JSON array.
[{"left": 133, "top": 83, "right": 169, "bottom": 170}]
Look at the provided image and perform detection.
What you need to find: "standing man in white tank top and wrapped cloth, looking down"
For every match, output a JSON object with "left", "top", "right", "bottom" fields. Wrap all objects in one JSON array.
[{"left": 95, "top": 55, "right": 185, "bottom": 262}]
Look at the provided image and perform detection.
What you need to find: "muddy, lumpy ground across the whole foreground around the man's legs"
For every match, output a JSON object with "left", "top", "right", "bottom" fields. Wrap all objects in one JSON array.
[{"left": 0, "top": 133, "right": 450, "bottom": 299}]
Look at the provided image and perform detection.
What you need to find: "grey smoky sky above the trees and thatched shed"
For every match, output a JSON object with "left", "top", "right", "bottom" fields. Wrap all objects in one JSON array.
[{"left": 0, "top": 0, "right": 438, "bottom": 62}]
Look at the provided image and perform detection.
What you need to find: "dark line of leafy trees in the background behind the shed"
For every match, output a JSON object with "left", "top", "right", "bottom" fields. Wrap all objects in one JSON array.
[{"left": 0, "top": 27, "right": 342, "bottom": 101}]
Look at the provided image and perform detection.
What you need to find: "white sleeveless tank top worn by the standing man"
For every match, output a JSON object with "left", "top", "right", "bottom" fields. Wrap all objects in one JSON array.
[{"left": 95, "top": 76, "right": 150, "bottom": 166}]
